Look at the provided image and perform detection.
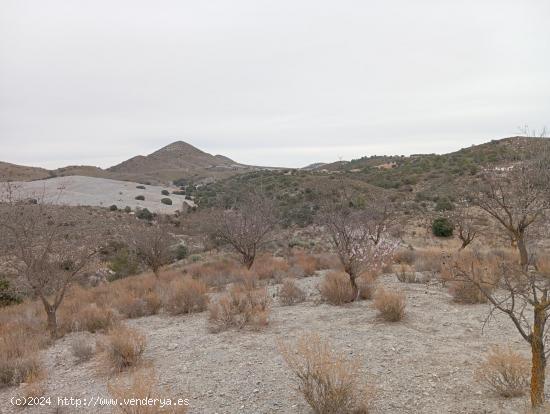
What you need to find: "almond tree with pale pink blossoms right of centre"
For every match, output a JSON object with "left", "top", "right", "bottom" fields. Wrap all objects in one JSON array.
[{"left": 318, "top": 203, "right": 397, "bottom": 297}]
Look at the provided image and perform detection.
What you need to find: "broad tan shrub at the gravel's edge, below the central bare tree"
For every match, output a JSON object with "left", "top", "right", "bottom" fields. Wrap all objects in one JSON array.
[{"left": 208, "top": 284, "right": 270, "bottom": 332}]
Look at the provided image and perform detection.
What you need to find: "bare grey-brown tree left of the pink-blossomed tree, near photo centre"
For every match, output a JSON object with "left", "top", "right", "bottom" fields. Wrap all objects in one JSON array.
[{"left": 210, "top": 193, "right": 278, "bottom": 269}]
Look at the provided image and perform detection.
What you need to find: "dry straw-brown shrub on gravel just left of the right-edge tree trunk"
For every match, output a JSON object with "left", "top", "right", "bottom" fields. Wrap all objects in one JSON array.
[{"left": 475, "top": 347, "right": 531, "bottom": 398}]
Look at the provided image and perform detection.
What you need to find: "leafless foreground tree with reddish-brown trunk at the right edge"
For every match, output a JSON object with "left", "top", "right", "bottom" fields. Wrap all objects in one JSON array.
[{"left": 453, "top": 260, "right": 550, "bottom": 407}]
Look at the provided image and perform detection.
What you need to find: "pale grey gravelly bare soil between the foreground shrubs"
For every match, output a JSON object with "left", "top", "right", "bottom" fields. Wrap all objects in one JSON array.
[{"left": 0, "top": 276, "right": 544, "bottom": 414}]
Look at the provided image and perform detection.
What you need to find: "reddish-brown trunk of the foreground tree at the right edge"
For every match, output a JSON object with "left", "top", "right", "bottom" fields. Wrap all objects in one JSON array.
[{"left": 531, "top": 306, "right": 546, "bottom": 407}]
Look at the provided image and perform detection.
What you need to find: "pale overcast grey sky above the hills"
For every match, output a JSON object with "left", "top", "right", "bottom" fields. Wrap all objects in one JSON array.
[{"left": 0, "top": 0, "right": 550, "bottom": 167}]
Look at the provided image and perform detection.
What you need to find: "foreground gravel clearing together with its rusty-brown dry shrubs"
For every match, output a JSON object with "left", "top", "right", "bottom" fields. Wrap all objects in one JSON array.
[{"left": 0, "top": 248, "right": 548, "bottom": 413}]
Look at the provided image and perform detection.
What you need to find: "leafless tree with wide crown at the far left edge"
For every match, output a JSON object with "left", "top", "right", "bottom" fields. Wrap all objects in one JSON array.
[{"left": 0, "top": 188, "right": 100, "bottom": 338}]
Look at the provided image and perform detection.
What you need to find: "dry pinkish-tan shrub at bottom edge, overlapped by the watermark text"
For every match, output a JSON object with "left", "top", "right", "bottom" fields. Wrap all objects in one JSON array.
[{"left": 107, "top": 370, "right": 189, "bottom": 414}]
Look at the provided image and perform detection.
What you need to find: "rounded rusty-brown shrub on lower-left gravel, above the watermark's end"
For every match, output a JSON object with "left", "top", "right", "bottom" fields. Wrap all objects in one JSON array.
[{"left": 104, "top": 325, "right": 146, "bottom": 372}]
